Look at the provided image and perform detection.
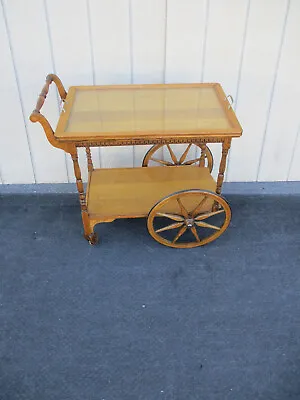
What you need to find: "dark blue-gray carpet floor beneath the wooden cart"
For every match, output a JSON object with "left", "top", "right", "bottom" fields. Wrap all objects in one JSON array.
[{"left": 0, "top": 195, "right": 300, "bottom": 400}]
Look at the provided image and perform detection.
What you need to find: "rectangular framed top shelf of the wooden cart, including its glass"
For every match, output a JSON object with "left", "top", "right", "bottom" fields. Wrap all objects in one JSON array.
[{"left": 55, "top": 83, "right": 242, "bottom": 141}]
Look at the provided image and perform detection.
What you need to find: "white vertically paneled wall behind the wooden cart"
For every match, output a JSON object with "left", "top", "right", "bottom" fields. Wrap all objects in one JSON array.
[{"left": 0, "top": 0, "right": 300, "bottom": 183}]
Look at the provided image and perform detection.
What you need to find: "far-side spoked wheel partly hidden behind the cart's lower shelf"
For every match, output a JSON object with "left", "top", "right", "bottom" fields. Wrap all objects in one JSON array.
[{"left": 143, "top": 143, "right": 214, "bottom": 172}]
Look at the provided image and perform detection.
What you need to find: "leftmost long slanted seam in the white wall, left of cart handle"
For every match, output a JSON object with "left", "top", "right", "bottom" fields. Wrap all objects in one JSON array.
[{"left": 1, "top": 0, "right": 37, "bottom": 183}]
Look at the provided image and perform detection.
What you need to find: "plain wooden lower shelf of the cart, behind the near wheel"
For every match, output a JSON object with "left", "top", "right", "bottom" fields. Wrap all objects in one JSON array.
[{"left": 87, "top": 166, "right": 216, "bottom": 222}]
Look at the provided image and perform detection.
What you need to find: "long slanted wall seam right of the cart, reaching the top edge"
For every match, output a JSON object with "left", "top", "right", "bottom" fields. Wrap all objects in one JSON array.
[{"left": 256, "top": 0, "right": 290, "bottom": 181}]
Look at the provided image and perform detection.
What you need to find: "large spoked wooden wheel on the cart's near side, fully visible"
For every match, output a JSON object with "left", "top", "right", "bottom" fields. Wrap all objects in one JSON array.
[{"left": 147, "top": 189, "right": 231, "bottom": 248}]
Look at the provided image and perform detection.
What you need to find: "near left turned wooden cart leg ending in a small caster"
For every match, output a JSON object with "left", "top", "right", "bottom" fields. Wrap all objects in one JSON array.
[{"left": 71, "top": 148, "right": 97, "bottom": 244}]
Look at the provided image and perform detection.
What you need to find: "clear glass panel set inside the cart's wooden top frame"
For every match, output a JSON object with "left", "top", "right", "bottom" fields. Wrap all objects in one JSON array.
[{"left": 66, "top": 86, "right": 231, "bottom": 133}]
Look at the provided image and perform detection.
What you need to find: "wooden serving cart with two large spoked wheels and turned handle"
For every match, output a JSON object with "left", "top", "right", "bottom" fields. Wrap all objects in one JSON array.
[{"left": 30, "top": 74, "right": 242, "bottom": 248}]
